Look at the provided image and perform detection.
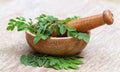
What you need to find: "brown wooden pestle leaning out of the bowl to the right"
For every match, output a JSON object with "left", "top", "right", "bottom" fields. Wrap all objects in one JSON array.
[{"left": 52, "top": 10, "right": 114, "bottom": 37}]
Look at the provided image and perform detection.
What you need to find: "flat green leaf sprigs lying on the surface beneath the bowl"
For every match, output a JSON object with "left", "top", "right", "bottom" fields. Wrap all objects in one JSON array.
[{"left": 20, "top": 52, "right": 83, "bottom": 70}]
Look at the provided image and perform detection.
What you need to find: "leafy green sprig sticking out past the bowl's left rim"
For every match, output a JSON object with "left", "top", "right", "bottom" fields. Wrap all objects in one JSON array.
[{"left": 7, "top": 17, "right": 35, "bottom": 33}]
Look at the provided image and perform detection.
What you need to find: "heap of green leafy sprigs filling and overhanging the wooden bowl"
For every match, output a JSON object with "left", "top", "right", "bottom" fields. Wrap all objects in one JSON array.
[{"left": 7, "top": 14, "right": 90, "bottom": 44}]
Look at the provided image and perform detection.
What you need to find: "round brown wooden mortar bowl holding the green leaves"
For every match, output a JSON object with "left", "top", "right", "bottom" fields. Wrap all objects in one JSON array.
[{"left": 25, "top": 31, "right": 87, "bottom": 56}]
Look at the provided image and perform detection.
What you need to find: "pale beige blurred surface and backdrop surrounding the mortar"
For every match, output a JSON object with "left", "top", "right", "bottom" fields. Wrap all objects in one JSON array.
[{"left": 0, "top": 0, "right": 120, "bottom": 72}]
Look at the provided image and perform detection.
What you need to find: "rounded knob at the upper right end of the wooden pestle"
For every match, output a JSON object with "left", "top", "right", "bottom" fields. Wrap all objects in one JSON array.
[{"left": 103, "top": 10, "right": 114, "bottom": 25}]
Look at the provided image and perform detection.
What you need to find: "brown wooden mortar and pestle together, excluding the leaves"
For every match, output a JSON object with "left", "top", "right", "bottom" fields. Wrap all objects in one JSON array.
[{"left": 25, "top": 10, "right": 113, "bottom": 56}]
